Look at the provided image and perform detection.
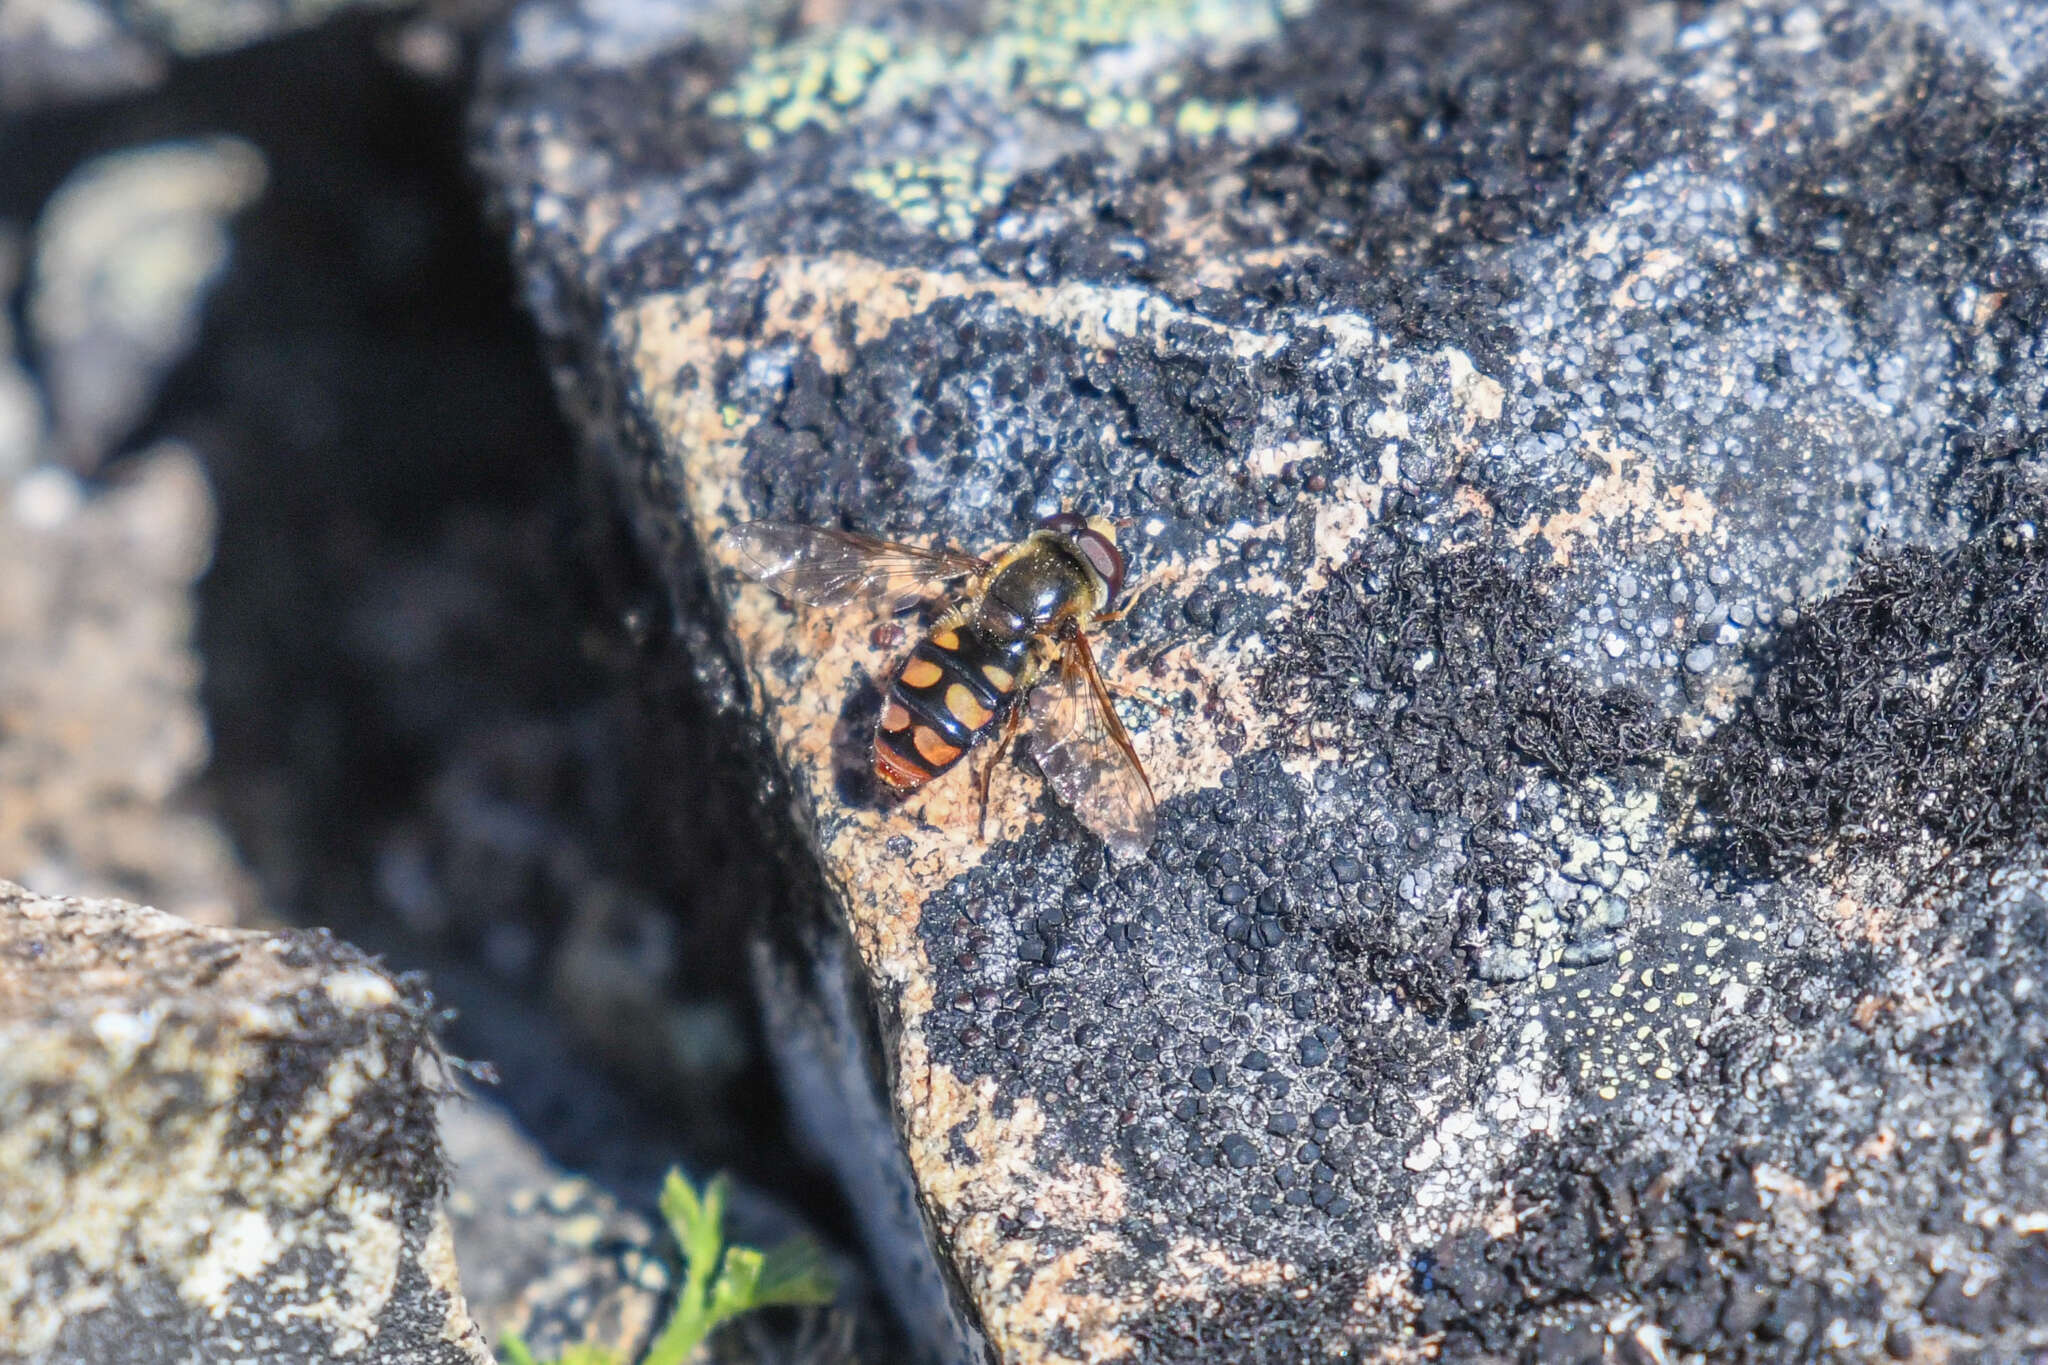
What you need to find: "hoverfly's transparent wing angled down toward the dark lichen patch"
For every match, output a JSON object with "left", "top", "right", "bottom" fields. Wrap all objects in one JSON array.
[{"left": 1030, "top": 634, "right": 1159, "bottom": 857}]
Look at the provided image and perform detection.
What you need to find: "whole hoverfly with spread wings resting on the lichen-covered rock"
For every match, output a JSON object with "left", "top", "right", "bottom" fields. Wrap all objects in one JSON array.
[{"left": 727, "top": 512, "right": 1159, "bottom": 857}]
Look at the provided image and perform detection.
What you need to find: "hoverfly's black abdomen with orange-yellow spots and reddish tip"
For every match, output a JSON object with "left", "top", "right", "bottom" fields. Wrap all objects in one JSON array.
[{"left": 874, "top": 622, "right": 1030, "bottom": 792}]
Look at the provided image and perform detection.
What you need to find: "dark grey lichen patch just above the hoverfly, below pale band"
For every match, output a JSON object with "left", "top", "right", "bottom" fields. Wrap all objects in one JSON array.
[{"left": 737, "top": 294, "right": 1290, "bottom": 553}]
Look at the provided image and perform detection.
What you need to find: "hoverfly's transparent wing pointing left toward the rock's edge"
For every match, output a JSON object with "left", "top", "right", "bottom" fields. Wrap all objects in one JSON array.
[{"left": 725, "top": 522, "right": 987, "bottom": 612}]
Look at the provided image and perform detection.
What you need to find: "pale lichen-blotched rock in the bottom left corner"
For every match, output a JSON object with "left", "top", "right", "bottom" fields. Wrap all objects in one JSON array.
[{"left": 0, "top": 886, "right": 492, "bottom": 1365}]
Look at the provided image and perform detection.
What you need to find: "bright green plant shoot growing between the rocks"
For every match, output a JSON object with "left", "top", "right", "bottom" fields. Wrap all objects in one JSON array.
[{"left": 502, "top": 1171, "right": 834, "bottom": 1365}]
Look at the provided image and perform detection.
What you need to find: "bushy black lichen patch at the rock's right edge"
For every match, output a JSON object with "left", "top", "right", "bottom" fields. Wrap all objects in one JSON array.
[{"left": 1696, "top": 489, "right": 2048, "bottom": 876}]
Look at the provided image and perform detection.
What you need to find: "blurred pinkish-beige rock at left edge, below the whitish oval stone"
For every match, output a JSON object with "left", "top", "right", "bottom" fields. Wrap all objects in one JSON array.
[{"left": 0, "top": 444, "right": 254, "bottom": 925}]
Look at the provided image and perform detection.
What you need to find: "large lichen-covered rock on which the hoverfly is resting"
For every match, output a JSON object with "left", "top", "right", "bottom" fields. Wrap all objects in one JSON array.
[{"left": 477, "top": 0, "right": 2048, "bottom": 1361}]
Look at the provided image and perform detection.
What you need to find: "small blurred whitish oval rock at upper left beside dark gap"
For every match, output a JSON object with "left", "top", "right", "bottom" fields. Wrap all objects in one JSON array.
[{"left": 29, "top": 137, "right": 264, "bottom": 473}]
